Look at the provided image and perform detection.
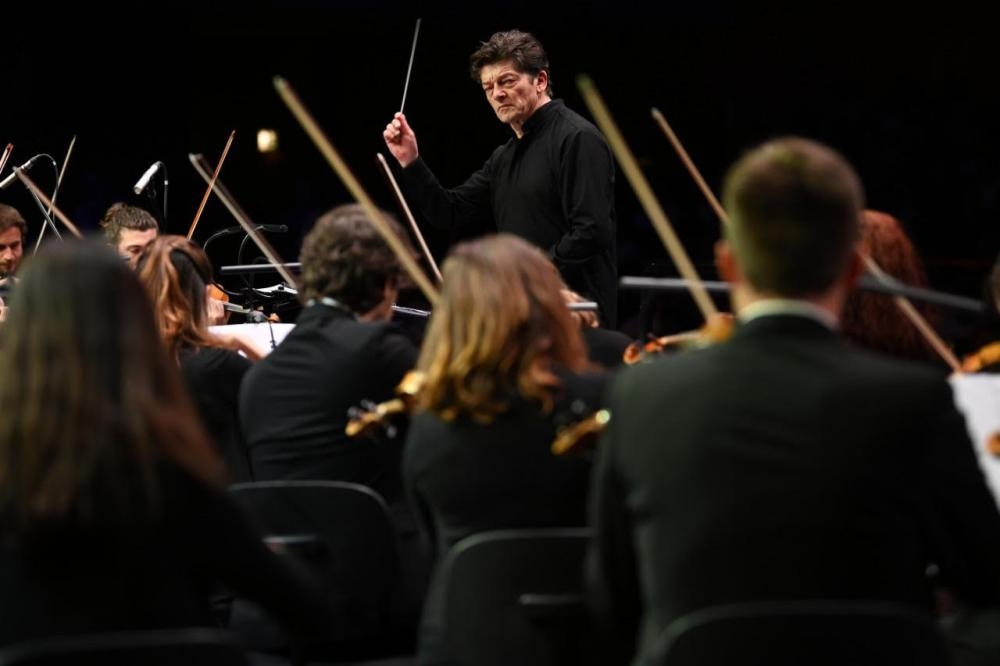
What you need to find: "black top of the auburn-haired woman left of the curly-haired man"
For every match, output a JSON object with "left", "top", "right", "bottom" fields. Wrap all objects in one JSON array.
[{"left": 180, "top": 347, "right": 253, "bottom": 483}]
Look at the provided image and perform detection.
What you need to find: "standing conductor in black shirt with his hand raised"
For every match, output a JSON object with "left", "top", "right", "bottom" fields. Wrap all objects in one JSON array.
[{"left": 382, "top": 30, "right": 617, "bottom": 328}]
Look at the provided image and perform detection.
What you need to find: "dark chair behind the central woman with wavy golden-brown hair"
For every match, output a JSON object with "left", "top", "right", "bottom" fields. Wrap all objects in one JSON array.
[{"left": 440, "top": 528, "right": 594, "bottom": 666}]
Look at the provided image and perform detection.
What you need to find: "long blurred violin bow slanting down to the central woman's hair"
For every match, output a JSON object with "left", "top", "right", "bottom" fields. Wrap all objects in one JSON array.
[{"left": 274, "top": 76, "right": 438, "bottom": 307}]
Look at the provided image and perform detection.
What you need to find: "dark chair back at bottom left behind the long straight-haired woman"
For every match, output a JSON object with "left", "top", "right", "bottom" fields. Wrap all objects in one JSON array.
[{"left": 0, "top": 627, "right": 250, "bottom": 666}]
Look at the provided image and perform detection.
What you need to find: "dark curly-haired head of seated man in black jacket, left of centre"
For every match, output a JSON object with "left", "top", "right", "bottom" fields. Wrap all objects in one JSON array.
[{"left": 299, "top": 204, "right": 408, "bottom": 315}]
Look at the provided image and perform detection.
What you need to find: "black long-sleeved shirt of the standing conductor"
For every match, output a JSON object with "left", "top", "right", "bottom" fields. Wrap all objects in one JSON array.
[{"left": 402, "top": 100, "right": 618, "bottom": 328}]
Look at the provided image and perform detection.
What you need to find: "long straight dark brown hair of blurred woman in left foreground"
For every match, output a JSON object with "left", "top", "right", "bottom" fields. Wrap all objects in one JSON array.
[{"left": 0, "top": 241, "right": 223, "bottom": 538}]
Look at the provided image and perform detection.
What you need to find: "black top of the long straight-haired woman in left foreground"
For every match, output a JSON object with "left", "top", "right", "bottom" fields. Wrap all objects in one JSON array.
[{"left": 0, "top": 464, "right": 335, "bottom": 645}]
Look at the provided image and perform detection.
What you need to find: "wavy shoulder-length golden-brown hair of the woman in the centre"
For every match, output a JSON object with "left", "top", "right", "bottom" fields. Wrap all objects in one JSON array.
[{"left": 417, "top": 234, "right": 587, "bottom": 422}]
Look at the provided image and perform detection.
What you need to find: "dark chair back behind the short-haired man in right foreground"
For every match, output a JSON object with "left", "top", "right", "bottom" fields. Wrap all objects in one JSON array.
[{"left": 645, "top": 600, "right": 950, "bottom": 666}]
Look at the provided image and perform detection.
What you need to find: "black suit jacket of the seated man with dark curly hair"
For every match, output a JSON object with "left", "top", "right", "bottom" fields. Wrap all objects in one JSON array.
[{"left": 240, "top": 305, "right": 417, "bottom": 502}]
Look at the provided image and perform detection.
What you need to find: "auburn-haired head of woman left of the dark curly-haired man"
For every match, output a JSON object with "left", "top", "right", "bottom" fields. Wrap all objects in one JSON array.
[{"left": 136, "top": 234, "right": 217, "bottom": 351}]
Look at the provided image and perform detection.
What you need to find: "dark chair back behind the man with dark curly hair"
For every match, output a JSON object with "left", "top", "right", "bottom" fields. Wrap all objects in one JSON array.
[{"left": 228, "top": 480, "right": 400, "bottom": 659}]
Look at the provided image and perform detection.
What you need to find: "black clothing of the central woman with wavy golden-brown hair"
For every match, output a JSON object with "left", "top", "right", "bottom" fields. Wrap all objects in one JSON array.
[{"left": 403, "top": 374, "right": 606, "bottom": 664}]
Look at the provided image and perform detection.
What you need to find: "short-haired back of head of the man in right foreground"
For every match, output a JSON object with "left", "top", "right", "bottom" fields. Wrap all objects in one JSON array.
[{"left": 723, "top": 137, "right": 864, "bottom": 298}]
